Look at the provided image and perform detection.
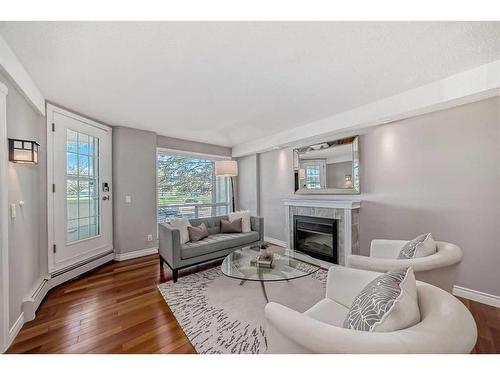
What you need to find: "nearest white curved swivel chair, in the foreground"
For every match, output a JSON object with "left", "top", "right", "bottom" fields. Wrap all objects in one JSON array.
[{"left": 265, "top": 266, "right": 477, "bottom": 353}]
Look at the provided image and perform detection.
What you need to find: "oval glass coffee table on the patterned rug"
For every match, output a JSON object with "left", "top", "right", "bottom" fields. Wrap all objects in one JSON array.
[{"left": 221, "top": 247, "right": 321, "bottom": 302}]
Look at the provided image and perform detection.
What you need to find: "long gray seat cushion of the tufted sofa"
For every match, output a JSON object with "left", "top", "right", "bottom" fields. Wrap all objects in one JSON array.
[{"left": 181, "top": 232, "right": 259, "bottom": 259}]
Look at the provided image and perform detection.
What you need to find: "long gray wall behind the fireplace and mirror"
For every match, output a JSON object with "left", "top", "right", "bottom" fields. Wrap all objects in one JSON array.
[{"left": 239, "top": 97, "right": 500, "bottom": 296}]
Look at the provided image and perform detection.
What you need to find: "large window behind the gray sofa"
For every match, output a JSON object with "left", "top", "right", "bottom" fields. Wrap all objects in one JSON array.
[{"left": 157, "top": 151, "right": 229, "bottom": 223}]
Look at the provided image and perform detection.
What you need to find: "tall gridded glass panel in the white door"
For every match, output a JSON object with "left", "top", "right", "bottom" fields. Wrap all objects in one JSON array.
[{"left": 66, "top": 129, "right": 100, "bottom": 244}]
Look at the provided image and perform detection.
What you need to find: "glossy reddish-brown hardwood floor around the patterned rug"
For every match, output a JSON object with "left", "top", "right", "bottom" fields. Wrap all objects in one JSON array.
[{"left": 8, "top": 255, "right": 500, "bottom": 353}]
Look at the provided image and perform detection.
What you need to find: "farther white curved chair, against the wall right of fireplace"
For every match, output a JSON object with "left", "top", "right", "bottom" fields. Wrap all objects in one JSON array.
[{"left": 347, "top": 240, "right": 463, "bottom": 293}]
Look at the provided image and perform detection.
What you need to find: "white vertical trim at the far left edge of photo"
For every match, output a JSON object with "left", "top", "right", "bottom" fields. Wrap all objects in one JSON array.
[{"left": 0, "top": 82, "right": 10, "bottom": 353}]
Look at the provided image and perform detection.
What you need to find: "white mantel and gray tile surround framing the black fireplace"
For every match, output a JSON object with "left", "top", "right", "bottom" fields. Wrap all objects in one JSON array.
[{"left": 283, "top": 199, "right": 361, "bottom": 265}]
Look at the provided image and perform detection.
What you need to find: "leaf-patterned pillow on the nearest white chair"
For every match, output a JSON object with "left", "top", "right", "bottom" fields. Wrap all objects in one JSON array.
[{"left": 343, "top": 267, "right": 420, "bottom": 332}]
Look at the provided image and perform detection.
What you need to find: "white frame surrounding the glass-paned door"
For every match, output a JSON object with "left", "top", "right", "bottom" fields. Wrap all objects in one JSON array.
[{"left": 46, "top": 103, "right": 114, "bottom": 275}]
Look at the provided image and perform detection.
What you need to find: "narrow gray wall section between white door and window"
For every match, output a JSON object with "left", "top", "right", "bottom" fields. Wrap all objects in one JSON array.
[{"left": 113, "top": 126, "right": 157, "bottom": 254}]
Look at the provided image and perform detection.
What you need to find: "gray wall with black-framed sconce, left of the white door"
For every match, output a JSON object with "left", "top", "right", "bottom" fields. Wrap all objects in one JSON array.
[{"left": 0, "top": 74, "right": 47, "bottom": 327}]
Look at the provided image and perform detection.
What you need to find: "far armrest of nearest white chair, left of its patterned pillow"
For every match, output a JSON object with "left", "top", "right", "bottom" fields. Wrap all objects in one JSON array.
[{"left": 326, "top": 266, "right": 380, "bottom": 308}]
